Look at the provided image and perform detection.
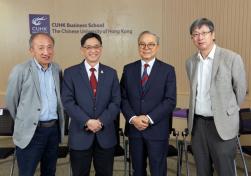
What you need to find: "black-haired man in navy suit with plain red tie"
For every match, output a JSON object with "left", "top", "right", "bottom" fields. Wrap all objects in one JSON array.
[{"left": 62, "top": 33, "right": 121, "bottom": 176}]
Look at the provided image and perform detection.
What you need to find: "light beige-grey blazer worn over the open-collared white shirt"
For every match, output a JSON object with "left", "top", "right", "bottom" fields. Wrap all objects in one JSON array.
[{"left": 186, "top": 46, "right": 247, "bottom": 140}]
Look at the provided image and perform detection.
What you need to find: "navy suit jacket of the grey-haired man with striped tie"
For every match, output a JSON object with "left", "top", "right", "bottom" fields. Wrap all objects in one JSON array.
[{"left": 120, "top": 59, "right": 176, "bottom": 140}]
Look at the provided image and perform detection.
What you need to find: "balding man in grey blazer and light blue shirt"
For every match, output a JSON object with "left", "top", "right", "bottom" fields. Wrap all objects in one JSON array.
[{"left": 6, "top": 33, "right": 64, "bottom": 176}]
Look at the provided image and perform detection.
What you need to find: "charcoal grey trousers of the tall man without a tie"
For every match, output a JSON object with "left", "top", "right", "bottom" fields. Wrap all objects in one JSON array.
[{"left": 192, "top": 117, "right": 236, "bottom": 176}]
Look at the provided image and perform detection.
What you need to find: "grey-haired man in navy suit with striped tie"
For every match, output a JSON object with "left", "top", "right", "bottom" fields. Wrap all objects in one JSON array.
[{"left": 120, "top": 31, "right": 176, "bottom": 176}]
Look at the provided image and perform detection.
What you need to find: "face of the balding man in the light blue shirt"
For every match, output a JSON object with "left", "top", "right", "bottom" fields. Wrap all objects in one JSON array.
[{"left": 30, "top": 34, "right": 54, "bottom": 68}]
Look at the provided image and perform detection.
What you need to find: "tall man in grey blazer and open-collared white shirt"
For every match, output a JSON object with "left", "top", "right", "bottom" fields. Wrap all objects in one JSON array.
[{"left": 186, "top": 18, "right": 247, "bottom": 176}]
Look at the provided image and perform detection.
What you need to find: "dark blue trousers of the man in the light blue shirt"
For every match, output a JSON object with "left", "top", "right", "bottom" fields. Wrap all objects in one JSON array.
[{"left": 16, "top": 124, "right": 59, "bottom": 176}]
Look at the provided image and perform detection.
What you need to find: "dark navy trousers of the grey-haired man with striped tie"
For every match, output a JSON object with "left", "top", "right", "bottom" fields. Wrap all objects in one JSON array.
[{"left": 129, "top": 138, "right": 168, "bottom": 176}]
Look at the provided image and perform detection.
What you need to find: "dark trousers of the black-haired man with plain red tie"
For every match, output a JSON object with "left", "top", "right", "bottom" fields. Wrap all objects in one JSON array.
[{"left": 70, "top": 138, "right": 115, "bottom": 176}]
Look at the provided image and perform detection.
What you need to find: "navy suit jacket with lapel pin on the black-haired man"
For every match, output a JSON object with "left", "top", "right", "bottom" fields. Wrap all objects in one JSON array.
[{"left": 62, "top": 62, "right": 121, "bottom": 150}]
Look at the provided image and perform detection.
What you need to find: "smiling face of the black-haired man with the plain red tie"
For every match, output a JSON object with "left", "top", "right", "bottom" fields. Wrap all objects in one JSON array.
[{"left": 81, "top": 37, "right": 102, "bottom": 65}]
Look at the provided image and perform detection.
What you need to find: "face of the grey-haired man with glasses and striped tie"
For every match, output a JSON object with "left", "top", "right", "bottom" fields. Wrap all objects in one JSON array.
[{"left": 138, "top": 34, "right": 159, "bottom": 62}]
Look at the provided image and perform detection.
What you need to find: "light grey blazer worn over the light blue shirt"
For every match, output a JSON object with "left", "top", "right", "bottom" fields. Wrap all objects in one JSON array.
[{"left": 5, "top": 59, "right": 64, "bottom": 148}]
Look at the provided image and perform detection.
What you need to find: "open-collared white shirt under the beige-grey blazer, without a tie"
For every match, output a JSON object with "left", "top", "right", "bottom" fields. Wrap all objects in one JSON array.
[{"left": 195, "top": 45, "right": 216, "bottom": 117}]
